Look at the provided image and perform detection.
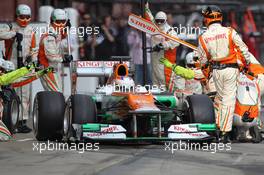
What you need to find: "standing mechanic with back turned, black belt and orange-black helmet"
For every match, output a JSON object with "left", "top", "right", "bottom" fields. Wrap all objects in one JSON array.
[{"left": 198, "top": 5, "right": 253, "bottom": 142}]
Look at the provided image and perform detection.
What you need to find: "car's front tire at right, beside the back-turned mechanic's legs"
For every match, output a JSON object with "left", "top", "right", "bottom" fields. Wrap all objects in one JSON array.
[{"left": 186, "top": 95, "right": 215, "bottom": 124}]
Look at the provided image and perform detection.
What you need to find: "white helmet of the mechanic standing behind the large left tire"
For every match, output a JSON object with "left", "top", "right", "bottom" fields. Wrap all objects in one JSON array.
[{"left": 50, "top": 9, "right": 68, "bottom": 31}]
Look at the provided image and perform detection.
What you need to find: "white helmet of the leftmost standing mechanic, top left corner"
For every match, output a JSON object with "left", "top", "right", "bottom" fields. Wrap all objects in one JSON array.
[{"left": 16, "top": 4, "right": 31, "bottom": 27}]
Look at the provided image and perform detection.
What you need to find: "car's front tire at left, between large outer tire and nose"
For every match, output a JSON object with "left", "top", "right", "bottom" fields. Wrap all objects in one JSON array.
[{"left": 71, "top": 94, "right": 96, "bottom": 124}]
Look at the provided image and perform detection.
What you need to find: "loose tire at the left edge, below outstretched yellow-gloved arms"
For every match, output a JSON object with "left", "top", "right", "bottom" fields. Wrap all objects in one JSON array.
[{"left": 2, "top": 89, "right": 19, "bottom": 134}]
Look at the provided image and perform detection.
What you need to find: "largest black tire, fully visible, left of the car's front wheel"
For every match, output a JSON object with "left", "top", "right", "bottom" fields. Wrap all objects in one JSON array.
[{"left": 33, "top": 91, "right": 65, "bottom": 141}]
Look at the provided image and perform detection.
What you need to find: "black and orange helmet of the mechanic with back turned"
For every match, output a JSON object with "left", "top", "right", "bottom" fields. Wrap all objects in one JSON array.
[{"left": 202, "top": 5, "right": 223, "bottom": 27}]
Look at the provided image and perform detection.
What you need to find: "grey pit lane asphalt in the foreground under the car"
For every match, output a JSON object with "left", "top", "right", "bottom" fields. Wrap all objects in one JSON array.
[{"left": 0, "top": 133, "right": 264, "bottom": 175}]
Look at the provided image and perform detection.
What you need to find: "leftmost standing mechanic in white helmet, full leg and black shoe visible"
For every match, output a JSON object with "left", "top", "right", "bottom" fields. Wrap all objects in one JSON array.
[{"left": 0, "top": 4, "right": 38, "bottom": 133}]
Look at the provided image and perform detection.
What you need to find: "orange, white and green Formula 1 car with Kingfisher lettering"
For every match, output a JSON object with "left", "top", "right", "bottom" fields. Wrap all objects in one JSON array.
[{"left": 33, "top": 61, "right": 216, "bottom": 141}]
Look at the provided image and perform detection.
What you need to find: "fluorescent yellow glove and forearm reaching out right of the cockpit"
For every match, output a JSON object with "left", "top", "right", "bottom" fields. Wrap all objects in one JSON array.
[{"left": 160, "top": 58, "right": 194, "bottom": 79}]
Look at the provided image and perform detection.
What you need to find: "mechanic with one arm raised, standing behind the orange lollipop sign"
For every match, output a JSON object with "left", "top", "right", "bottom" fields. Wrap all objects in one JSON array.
[{"left": 145, "top": 3, "right": 184, "bottom": 92}]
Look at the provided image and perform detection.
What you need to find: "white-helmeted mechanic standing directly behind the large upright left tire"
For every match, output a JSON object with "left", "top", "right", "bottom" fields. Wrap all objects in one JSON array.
[{"left": 38, "top": 9, "right": 72, "bottom": 92}]
